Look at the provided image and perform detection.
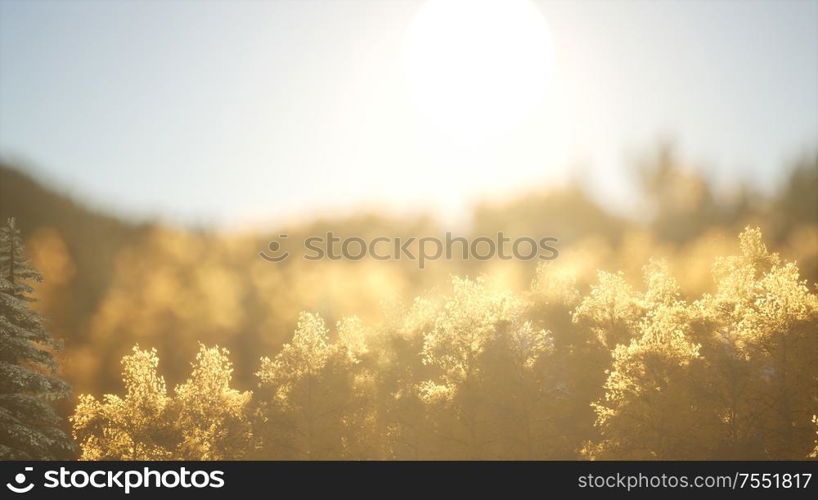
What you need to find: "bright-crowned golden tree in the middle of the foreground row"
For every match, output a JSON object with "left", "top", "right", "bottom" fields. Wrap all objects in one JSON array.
[{"left": 418, "top": 278, "right": 550, "bottom": 459}]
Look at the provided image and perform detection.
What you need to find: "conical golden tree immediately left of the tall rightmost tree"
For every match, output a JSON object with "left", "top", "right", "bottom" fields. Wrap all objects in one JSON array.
[{"left": 585, "top": 262, "right": 708, "bottom": 459}]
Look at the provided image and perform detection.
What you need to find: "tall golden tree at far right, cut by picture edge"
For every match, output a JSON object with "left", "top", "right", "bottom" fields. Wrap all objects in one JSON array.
[{"left": 696, "top": 228, "right": 818, "bottom": 459}]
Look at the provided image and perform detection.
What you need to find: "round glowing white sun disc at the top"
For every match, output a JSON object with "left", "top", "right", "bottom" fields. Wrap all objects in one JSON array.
[{"left": 404, "top": 0, "right": 553, "bottom": 141}]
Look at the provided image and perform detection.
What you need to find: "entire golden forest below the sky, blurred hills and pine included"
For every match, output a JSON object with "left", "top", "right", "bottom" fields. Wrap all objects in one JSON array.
[{"left": 0, "top": 149, "right": 818, "bottom": 460}]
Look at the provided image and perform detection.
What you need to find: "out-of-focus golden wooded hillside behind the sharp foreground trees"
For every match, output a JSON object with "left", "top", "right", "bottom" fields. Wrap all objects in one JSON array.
[{"left": 0, "top": 148, "right": 818, "bottom": 394}]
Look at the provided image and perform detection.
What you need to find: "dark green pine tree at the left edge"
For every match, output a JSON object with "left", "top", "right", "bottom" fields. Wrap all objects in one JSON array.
[{"left": 0, "top": 218, "right": 74, "bottom": 460}]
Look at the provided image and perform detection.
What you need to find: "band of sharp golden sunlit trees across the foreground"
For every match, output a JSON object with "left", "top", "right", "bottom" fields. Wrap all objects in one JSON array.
[{"left": 72, "top": 228, "right": 818, "bottom": 459}]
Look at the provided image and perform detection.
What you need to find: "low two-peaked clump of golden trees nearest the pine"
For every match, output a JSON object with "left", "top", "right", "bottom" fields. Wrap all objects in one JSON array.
[{"left": 71, "top": 345, "right": 251, "bottom": 460}]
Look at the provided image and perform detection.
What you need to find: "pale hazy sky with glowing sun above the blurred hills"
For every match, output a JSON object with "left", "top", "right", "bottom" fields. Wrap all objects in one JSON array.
[{"left": 0, "top": 0, "right": 818, "bottom": 224}]
